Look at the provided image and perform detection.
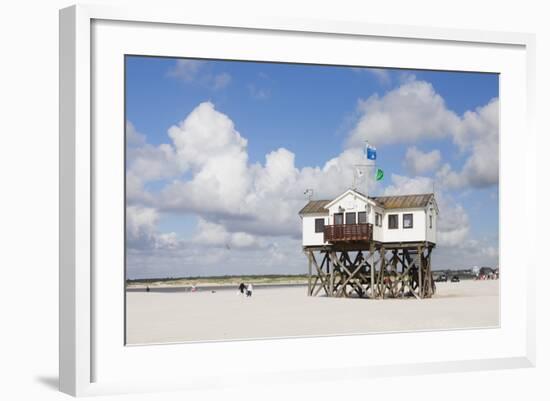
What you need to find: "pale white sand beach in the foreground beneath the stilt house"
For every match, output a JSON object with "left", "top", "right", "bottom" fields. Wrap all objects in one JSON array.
[{"left": 127, "top": 281, "right": 499, "bottom": 344}]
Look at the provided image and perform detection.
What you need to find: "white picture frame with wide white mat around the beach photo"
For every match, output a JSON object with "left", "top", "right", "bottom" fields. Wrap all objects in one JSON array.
[{"left": 59, "top": 5, "right": 536, "bottom": 395}]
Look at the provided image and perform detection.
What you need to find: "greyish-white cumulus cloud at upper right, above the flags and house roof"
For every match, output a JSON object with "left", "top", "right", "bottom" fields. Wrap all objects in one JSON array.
[{"left": 347, "top": 76, "right": 499, "bottom": 189}]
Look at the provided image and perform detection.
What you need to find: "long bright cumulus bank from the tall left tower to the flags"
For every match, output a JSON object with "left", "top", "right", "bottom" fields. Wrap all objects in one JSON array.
[{"left": 147, "top": 102, "right": 376, "bottom": 236}]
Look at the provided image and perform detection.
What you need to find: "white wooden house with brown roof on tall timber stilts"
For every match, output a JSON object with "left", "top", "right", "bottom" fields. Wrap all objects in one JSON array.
[{"left": 299, "top": 189, "right": 439, "bottom": 298}]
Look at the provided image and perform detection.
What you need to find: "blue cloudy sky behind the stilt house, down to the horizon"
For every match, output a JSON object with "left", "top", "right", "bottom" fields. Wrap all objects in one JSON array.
[{"left": 125, "top": 56, "right": 499, "bottom": 279}]
